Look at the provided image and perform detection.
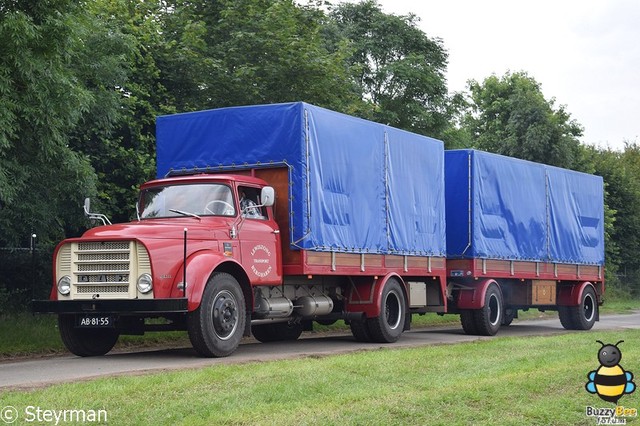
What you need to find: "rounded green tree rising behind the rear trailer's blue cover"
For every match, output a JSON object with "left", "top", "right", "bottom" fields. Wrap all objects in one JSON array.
[{"left": 464, "top": 72, "right": 583, "bottom": 169}]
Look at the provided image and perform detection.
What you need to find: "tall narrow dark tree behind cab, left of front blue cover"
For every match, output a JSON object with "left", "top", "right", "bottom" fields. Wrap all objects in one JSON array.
[{"left": 71, "top": 0, "right": 175, "bottom": 222}]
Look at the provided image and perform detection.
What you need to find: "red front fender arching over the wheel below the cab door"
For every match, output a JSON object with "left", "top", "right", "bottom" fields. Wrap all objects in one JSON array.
[{"left": 171, "top": 251, "right": 242, "bottom": 312}]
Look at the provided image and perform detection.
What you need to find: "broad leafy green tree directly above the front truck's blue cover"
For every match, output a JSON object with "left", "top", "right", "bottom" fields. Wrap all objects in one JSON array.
[{"left": 152, "top": 0, "right": 357, "bottom": 111}]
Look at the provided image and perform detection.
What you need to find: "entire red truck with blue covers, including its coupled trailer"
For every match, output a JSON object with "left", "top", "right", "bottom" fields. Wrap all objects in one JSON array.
[{"left": 33, "top": 102, "right": 604, "bottom": 357}]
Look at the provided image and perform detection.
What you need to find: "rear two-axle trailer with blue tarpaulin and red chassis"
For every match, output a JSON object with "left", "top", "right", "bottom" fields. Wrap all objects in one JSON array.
[{"left": 445, "top": 150, "right": 604, "bottom": 335}]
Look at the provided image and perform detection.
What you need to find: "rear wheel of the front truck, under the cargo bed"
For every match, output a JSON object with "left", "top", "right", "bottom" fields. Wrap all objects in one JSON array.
[{"left": 367, "top": 278, "right": 407, "bottom": 343}]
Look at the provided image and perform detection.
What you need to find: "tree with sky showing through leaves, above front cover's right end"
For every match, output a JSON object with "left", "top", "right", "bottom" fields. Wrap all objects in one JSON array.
[{"left": 326, "top": 0, "right": 452, "bottom": 137}]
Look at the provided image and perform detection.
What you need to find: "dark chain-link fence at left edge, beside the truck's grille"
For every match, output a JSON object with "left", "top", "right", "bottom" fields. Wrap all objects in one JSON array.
[{"left": 0, "top": 239, "right": 53, "bottom": 314}]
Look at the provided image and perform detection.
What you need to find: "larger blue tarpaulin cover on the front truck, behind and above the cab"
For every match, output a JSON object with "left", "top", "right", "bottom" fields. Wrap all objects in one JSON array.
[{"left": 157, "top": 102, "right": 446, "bottom": 256}]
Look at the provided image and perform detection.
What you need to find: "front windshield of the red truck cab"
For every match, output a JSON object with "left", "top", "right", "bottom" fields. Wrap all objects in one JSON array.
[{"left": 140, "top": 184, "right": 236, "bottom": 219}]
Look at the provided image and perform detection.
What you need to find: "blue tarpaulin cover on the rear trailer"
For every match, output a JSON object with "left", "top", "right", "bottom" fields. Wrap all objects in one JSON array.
[{"left": 445, "top": 150, "right": 604, "bottom": 265}]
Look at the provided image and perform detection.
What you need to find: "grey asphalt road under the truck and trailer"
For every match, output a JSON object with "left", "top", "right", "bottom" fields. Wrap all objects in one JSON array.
[{"left": 0, "top": 313, "right": 640, "bottom": 390}]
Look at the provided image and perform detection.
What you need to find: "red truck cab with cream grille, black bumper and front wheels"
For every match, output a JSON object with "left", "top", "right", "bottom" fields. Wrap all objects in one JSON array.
[{"left": 34, "top": 174, "right": 282, "bottom": 356}]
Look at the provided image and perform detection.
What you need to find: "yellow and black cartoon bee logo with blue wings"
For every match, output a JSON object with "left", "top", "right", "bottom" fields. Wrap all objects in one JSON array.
[{"left": 585, "top": 340, "right": 636, "bottom": 404}]
